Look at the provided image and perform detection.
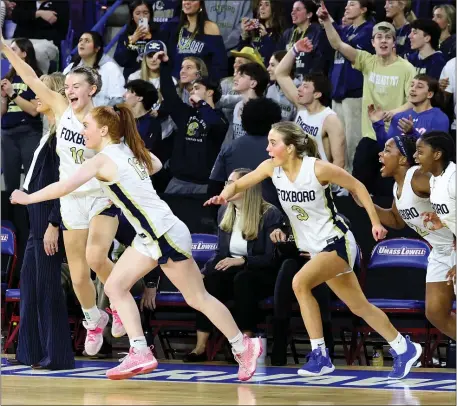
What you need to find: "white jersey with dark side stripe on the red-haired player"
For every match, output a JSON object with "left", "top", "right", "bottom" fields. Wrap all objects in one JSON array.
[{"left": 100, "top": 143, "right": 178, "bottom": 240}]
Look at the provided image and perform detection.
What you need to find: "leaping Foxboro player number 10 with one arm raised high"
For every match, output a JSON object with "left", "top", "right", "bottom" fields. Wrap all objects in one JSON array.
[{"left": 0, "top": 39, "right": 125, "bottom": 356}]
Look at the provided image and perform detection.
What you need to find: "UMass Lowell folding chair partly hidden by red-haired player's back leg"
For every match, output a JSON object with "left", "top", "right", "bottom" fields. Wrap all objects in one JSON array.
[{"left": 149, "top": 234, "right": 218, "bottom": 357}]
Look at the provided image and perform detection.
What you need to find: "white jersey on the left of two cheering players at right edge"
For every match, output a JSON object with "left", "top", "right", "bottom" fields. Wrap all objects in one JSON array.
[{"left": 394, "top": 166, "right": 454, "bottom": 251}]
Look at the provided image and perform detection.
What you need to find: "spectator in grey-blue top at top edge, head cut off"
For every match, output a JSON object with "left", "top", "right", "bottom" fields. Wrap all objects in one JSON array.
[{"left": 206, "top": 0, "right": 252, "bottom": 51}]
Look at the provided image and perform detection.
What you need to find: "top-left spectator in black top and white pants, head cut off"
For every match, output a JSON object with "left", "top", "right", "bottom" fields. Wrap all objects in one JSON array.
[{"left": 11, "top": 0, "right": 70, "bottom": 73}]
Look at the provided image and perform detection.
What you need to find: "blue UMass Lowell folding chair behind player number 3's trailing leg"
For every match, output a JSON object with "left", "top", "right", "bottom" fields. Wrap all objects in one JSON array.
[{"left": 350, "top": 238, "right": 430, "bottom": 365}]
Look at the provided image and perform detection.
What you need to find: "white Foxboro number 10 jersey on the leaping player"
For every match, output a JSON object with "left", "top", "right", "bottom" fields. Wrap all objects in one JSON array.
[{"left": 56, "top": 107, "right": 102, "bottom": 195}]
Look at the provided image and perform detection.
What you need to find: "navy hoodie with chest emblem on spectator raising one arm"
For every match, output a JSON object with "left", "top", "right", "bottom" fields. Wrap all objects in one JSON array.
[{"left": 160, "top": 62, "right": 229, "bottom": 184}]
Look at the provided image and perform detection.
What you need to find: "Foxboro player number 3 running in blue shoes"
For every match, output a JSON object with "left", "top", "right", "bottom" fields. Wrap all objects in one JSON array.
[{"left": 205, "top": 122, "right": 422, "bottom": 379}]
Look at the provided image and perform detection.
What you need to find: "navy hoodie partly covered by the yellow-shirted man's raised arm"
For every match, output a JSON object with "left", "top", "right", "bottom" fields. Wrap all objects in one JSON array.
[{"left": 331, "top": 20, "right": 374, "bottom": 101}]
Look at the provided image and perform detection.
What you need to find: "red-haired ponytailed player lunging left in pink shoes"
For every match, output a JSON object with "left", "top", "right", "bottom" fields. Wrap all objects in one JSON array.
[{"left": 12, "top": 105, "right": 263, "bottom": 381}]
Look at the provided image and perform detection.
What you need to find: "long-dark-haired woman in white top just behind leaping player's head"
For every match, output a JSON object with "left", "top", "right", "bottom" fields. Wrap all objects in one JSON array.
[{"left": 63, "top": 31, "right": 125, "bottom": 106}]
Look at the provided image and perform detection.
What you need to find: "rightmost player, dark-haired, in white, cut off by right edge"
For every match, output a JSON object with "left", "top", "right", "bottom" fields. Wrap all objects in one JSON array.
[{"left": 414, "top": 131, "right": 457, "bottom": 294}]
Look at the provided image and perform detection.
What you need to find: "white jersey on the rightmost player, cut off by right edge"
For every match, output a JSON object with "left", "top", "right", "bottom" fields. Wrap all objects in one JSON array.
[{"left": 430, "top": 162, "right": 455, "bottom": 235}]
